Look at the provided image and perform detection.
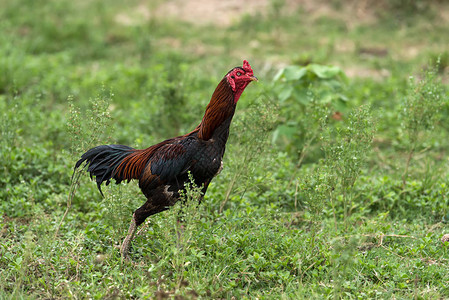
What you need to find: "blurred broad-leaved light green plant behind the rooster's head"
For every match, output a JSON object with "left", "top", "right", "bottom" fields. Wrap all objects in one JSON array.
[{"left": 273, "top": 64, "right": 347, "bottom": 160}]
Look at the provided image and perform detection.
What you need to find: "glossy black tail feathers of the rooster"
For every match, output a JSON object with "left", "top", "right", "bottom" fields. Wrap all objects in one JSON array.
[{"left": 72, "top": 145, "right": 135, "bottom": 196}]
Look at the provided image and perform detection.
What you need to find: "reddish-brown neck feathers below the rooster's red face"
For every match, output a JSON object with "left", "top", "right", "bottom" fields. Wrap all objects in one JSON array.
[{"left": 198, "top": 77, "right": 237, "bottom": 140}]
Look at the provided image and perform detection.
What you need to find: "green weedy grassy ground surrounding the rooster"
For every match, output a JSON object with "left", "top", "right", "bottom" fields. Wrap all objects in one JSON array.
[{"left": 0, "top": 0, "right": 449, "bottom": 299}]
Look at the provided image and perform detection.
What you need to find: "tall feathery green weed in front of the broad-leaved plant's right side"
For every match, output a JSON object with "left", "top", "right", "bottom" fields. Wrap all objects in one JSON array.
[{"left": 300, "top": 107, "right": 374, "bottom": 230}]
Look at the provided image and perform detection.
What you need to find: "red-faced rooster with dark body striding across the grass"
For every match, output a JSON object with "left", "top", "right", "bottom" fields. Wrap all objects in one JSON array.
[{"left": 74, "top": 60, "right": 257, "bottom": 258}]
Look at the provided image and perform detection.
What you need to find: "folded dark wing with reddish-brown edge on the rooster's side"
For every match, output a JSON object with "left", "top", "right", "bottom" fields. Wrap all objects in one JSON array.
[{"left": 139, "top": 136, "right": 199, "bottom": 190}]
